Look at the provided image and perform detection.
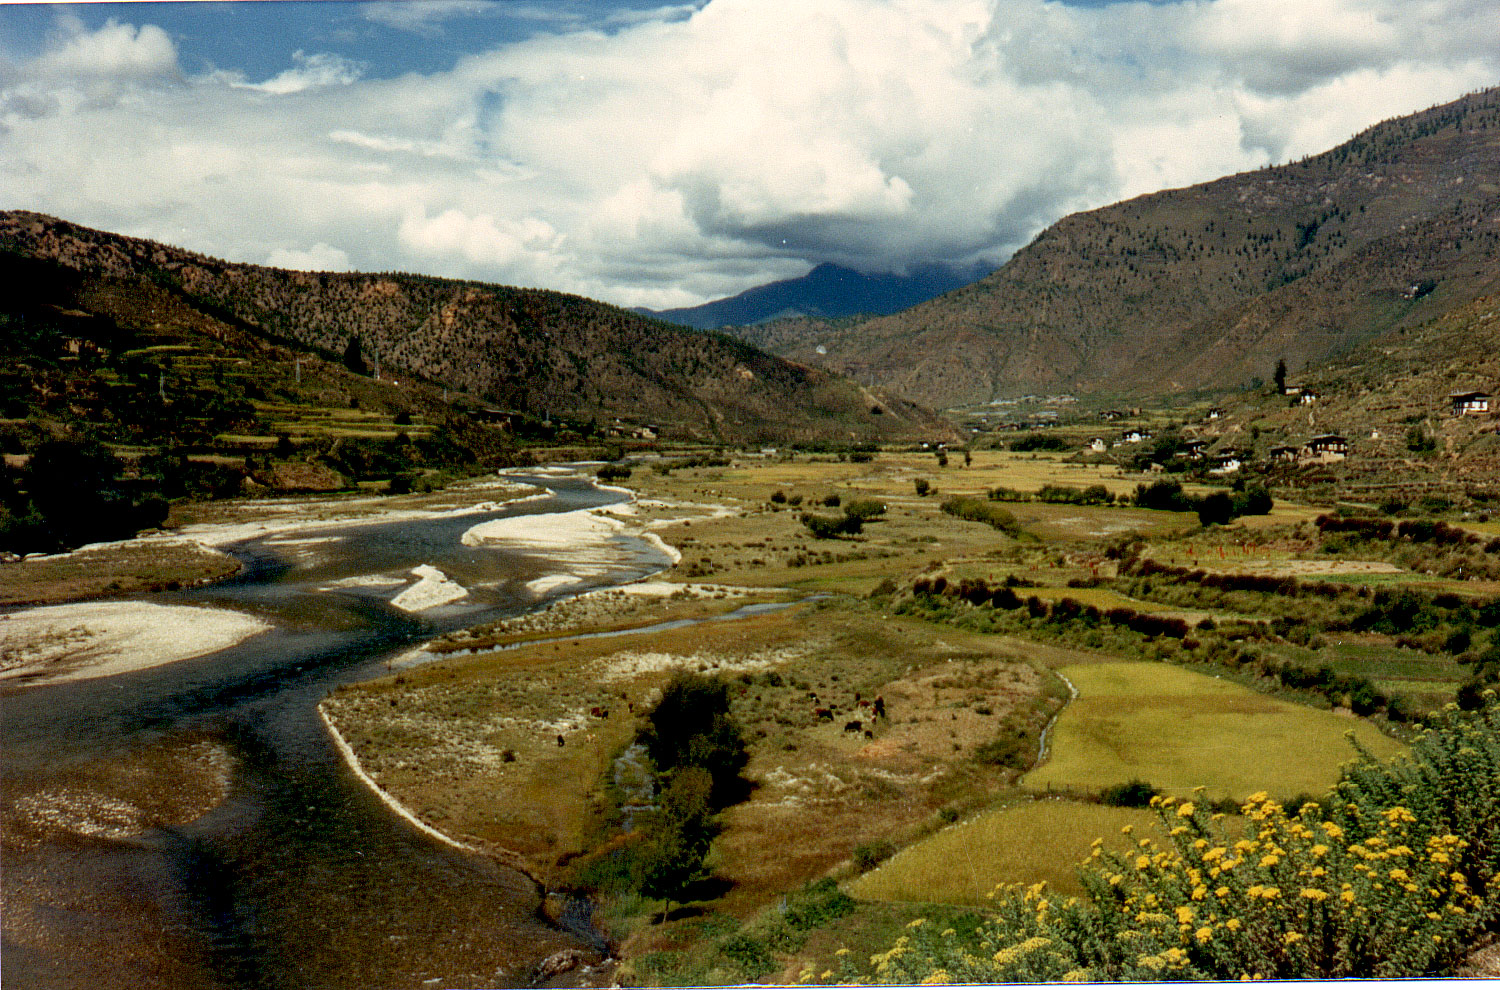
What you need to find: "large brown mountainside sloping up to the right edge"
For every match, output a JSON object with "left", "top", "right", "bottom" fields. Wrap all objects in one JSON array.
[{"left": 758, "top": 89, "right": 1500, "bottom": 407}]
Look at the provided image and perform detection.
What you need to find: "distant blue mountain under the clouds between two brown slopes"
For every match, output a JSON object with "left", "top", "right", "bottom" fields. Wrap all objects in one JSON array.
[{"left": 638, "top": 264, "right": 984, "bottom": 330}]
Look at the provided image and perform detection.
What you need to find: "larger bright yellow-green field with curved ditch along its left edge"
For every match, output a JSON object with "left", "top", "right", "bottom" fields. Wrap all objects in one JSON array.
[{"left": 1025, "top": 663, "right": 1401, "bottom": 800}]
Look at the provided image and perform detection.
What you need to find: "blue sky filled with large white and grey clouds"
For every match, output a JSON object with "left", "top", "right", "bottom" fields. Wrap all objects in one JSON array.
[{"left": 0, "top": 0, "right": 1500, "bottom": 309}]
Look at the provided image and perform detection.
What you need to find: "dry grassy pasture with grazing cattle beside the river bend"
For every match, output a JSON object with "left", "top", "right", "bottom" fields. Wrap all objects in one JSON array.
[{"left": 324, "top": 606, "right": 1062, "bottom": 911}]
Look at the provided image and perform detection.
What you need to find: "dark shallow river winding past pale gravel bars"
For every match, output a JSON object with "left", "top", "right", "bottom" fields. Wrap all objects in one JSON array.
[{"left": 0, "top": 476, "right": 669, "bottom": 990}]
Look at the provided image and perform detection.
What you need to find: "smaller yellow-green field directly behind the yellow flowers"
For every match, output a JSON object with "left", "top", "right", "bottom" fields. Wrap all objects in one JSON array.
[{"left": 849, "top": 800, "right": 1157, "bottom": 905}]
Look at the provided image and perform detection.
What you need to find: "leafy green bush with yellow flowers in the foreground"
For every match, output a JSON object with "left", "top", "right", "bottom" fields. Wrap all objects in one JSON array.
[{"left": 840, "top": 692, "right": 1500, "bottom": 984}]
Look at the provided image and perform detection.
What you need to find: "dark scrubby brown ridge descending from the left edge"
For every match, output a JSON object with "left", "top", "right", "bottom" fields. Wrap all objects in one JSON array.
[{"left": 0, "top": 212, "right": 951, "bottom": 443}]
